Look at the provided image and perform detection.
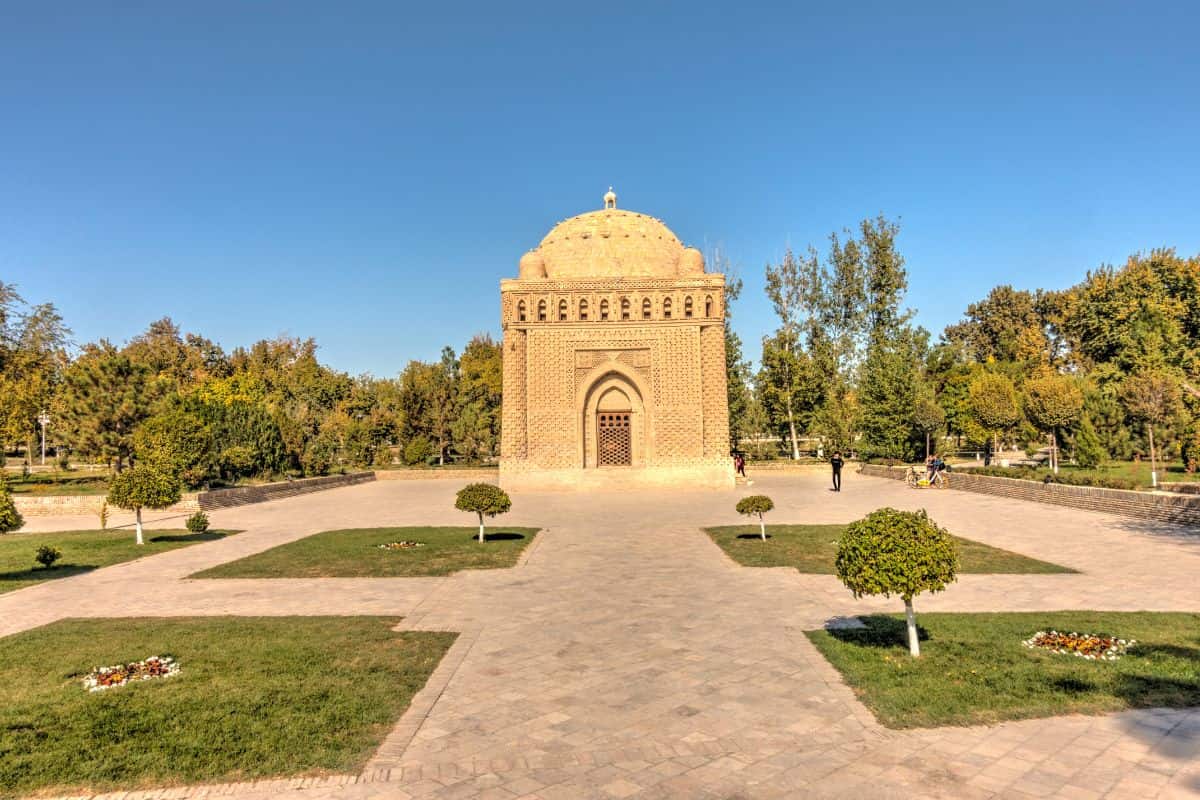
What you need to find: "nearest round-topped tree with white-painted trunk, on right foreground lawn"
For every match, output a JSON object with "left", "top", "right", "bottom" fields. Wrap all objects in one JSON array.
[{"left": 836, "top": 509, "right": 959, "bottom": 657}]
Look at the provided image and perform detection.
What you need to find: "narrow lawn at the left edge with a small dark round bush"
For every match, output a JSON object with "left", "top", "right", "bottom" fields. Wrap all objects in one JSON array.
[{"left": 0, "top": 529, "right": 234, "bottom": 594}]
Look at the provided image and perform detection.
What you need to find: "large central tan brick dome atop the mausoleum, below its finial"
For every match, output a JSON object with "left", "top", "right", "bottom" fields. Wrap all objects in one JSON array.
[{"left": 535, "top": 209, "right": 684, "bottom": 279}]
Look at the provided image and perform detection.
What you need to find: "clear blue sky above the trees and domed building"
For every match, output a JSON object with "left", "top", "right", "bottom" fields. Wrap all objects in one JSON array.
[{"left": 0, "top": 0, "right": 1200, "bottom": 375}]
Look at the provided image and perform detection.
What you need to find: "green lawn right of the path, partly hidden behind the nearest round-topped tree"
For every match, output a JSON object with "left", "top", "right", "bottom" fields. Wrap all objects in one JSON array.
[{"left": 704, "top": 525, "right": 1074, "bottom": 575}]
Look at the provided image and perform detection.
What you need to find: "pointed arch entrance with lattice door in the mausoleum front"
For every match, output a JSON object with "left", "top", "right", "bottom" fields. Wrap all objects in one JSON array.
[{"left": 580, "top": 367, "right": 649, "bottom": 469}]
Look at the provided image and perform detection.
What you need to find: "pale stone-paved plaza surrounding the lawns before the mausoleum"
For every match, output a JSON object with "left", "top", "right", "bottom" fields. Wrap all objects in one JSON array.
[{"left": 9, "top": 474, "right": 1200, "bottom": 800}]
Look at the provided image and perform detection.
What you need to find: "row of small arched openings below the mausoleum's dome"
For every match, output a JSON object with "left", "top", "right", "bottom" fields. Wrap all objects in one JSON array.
[{"left": 506, "top": 294, "right": 720, "bottom": 324}]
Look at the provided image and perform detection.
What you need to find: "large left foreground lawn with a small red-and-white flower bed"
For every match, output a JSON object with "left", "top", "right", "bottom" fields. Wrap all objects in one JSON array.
[{"left": 0, "top": 616, "right": 457, "bottom": 798}]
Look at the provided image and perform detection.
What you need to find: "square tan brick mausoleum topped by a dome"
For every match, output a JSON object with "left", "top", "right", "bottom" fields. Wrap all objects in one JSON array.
[{"left": 500, "top": 190, "right": 733, "bottom": 488}]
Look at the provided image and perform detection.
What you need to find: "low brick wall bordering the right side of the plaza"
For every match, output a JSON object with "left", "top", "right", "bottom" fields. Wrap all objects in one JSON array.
[{"left": 859, "top": 464, "right": 1200, "bottom": 525}]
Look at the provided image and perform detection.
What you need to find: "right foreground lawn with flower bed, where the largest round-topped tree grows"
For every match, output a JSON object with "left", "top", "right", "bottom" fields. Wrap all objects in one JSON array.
[{"left": 808, "top": 614, "right": 1200, "bottom": 728}]
